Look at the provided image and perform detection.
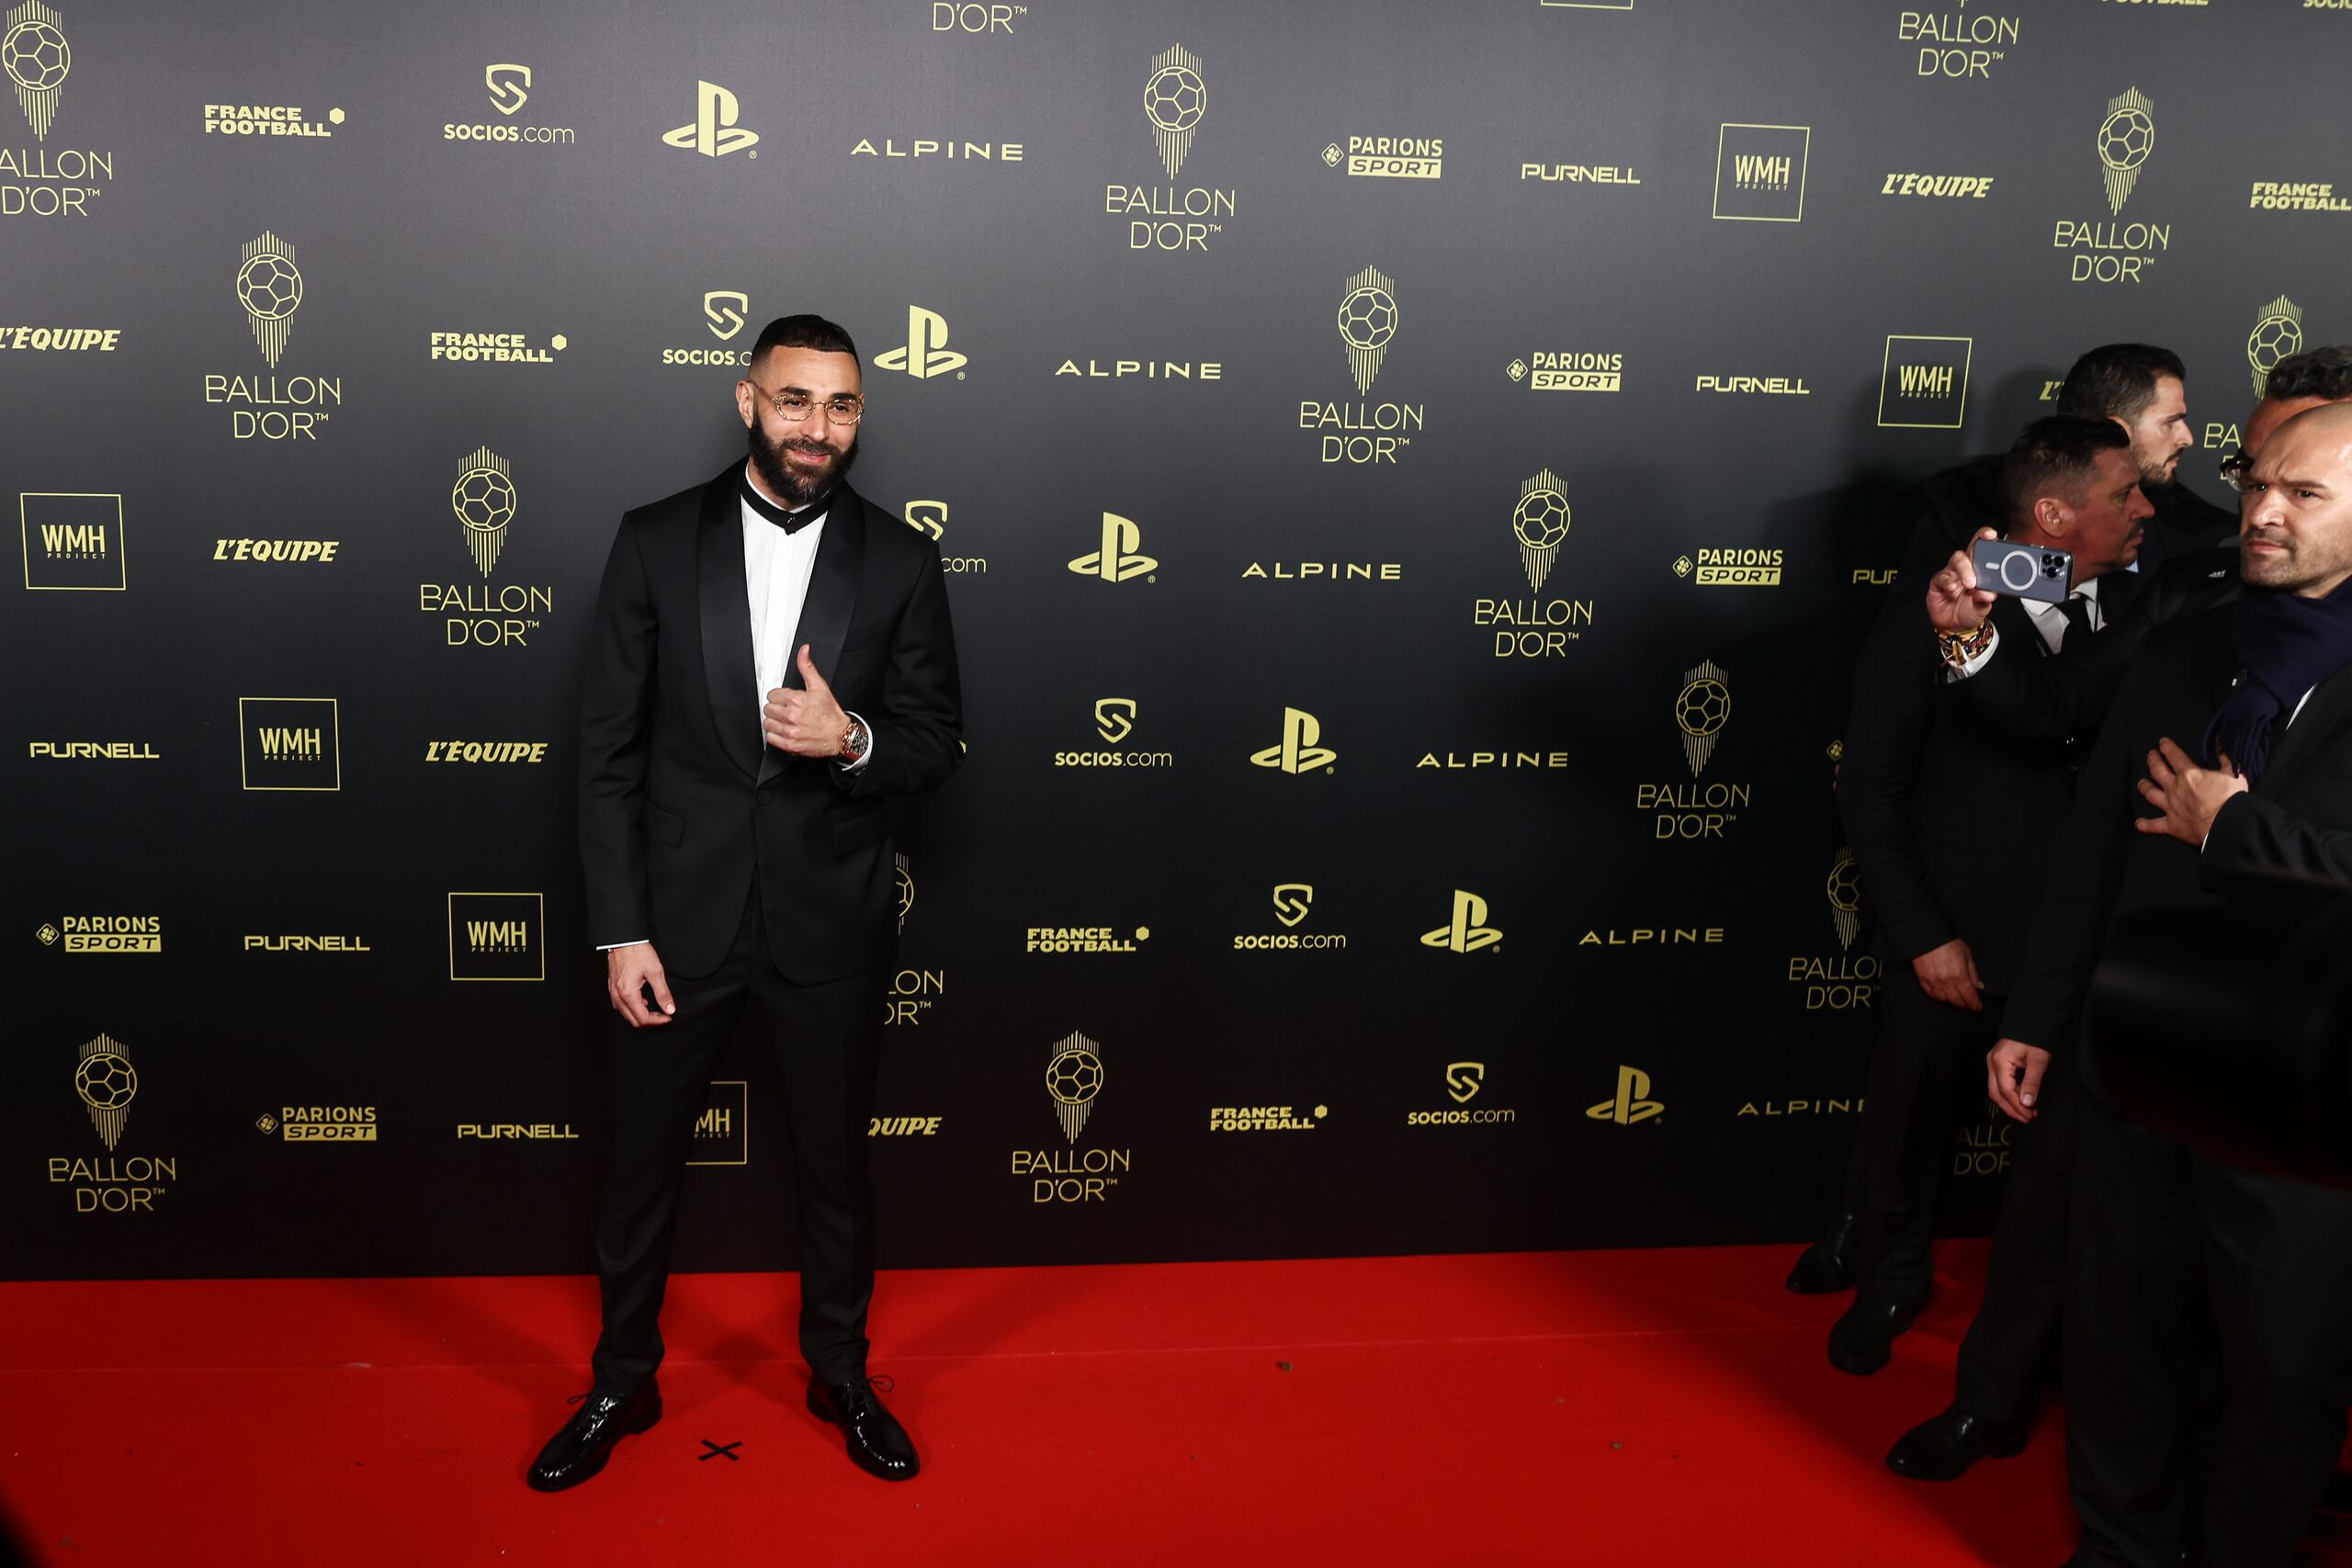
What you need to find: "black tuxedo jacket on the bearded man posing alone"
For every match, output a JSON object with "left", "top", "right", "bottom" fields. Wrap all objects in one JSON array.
[{"left": 579, "top": 461, "right": 965, "bottom": 985}]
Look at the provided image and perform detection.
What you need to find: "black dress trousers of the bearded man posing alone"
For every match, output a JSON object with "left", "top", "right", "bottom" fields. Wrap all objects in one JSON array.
[{"left": 595, "top": 879, "right": 887, "bottom": 1394}]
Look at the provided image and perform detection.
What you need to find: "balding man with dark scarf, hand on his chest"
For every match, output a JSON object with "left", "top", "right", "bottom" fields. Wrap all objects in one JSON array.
[{"left": 1985, "top": 404, "right": 2352, "bottom": 1568}]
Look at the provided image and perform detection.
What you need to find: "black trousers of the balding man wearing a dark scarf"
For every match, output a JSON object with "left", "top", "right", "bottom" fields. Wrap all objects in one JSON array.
[{"left": 2065, "top": 1093, "right": 2352, "bottom": 1568}]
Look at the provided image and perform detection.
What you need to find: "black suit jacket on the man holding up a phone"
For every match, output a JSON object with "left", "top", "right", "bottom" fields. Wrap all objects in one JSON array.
[{"left": 1837, "top": 573, "right": 2141, "bottom": 997}]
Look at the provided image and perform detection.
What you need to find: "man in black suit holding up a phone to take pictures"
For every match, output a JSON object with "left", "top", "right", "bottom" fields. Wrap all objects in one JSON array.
[{"left": 1830, "top": 413, "right": 2150, "bottom": 1401}]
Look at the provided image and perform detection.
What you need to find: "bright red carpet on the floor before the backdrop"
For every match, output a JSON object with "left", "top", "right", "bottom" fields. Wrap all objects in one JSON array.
[{"left": 0, "top": 1244, "right": 2342, "bottom": 1568}]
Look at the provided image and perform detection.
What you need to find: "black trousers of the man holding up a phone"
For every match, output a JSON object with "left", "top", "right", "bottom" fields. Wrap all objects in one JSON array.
[{"left": 1853, "top": 964, "right": 2002, "bottom": 1303}]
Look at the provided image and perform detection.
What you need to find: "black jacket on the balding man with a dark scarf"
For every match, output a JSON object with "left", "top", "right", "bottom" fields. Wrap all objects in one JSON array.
[{"left": 2002, "top": 606, "right": 2352, "bottom": 1054}]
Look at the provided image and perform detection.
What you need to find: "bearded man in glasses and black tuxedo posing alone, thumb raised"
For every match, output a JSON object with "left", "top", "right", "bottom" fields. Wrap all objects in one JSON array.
[{"left": 529, "top": 315, "right": 962, "bottom": 1491}]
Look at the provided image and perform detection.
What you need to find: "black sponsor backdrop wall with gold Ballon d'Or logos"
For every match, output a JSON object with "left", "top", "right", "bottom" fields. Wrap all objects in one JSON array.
[{"left": 0, "top": 0, "right": 2352, "bottom": 1277}]
